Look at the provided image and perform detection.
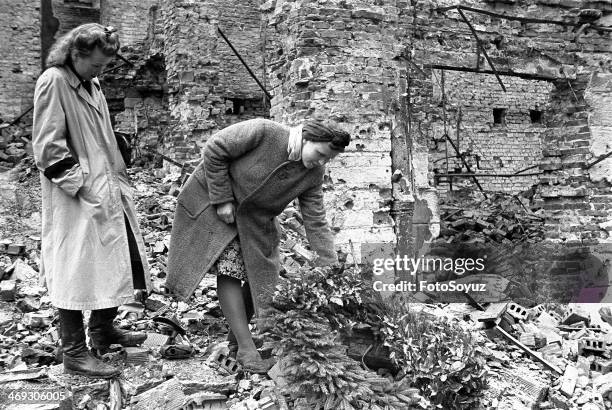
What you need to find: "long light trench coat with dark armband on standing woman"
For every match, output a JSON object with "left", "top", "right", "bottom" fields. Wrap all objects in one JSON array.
[{"left": 32, "top": 67, "right": 151, "bottom": 310}]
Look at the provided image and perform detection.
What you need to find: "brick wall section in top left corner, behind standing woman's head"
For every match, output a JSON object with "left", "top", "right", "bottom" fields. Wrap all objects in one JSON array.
[{"left": 0, "top": 0, "right": 41, "bottom": 122}]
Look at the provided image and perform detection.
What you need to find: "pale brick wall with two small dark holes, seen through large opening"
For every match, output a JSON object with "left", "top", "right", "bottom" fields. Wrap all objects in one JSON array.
[{"left": 430, "top": 70, "right": 553, "bottom": 193}]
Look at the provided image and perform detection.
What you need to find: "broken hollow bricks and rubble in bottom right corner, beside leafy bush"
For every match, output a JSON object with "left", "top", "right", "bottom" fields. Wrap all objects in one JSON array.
[{"left": 466, "top": 302, "right": 612, "bottom": 410}]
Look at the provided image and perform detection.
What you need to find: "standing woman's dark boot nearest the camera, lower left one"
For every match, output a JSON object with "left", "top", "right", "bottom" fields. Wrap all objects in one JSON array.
[{"left": 58, "top": 309, "right": 121, "bottom": 379}]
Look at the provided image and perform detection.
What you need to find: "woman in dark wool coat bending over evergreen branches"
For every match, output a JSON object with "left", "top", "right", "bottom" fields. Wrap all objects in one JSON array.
[{"left": 166, "top": 119, "right": 350, "bottom": 372}]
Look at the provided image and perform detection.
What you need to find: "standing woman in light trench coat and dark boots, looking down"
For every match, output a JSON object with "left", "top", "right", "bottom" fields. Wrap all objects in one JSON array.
[{"left": 32, "top": 23, "right": 151, "bottom": 378}]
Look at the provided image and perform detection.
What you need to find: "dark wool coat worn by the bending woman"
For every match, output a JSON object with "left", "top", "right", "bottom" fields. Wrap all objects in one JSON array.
[{"left": 166, "top": 119, "right": 337, "bottom": 309}]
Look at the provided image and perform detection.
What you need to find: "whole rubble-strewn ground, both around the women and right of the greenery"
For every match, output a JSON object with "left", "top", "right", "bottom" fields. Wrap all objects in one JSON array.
[{"left": 0, "top": 160, "right": 612, "bottom": 410}]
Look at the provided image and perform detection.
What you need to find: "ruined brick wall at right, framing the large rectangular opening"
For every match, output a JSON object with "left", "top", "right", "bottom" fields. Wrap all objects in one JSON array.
[{"left": 404, "top": 0, "right": 612, "bottom": 292}]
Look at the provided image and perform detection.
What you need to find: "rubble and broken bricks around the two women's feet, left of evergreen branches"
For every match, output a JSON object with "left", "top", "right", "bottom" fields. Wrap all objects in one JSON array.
[{"left": 0, "top": 164, "right": 300, "bottom": 410}]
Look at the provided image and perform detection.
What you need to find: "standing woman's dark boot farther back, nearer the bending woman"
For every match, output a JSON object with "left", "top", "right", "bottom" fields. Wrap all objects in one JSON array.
[{"left": 88, "top": 307, "right": 147, "bottom": 351}]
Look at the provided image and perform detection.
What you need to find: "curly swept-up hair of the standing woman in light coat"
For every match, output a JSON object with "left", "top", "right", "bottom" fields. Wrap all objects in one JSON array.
[{"left": 46, "top": 23, "right": 119, "bottom": 67}]
